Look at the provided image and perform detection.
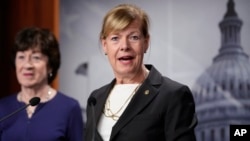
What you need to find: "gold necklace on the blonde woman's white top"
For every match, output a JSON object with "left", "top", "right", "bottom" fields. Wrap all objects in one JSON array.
[{"left": 103, "top": 84, "right": 141, "bottom": 121}]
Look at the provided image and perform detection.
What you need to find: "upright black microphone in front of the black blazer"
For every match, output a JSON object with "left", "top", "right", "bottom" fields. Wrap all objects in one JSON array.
[{"left": 88, "top": 96, "right": 96, "bottom": 141}]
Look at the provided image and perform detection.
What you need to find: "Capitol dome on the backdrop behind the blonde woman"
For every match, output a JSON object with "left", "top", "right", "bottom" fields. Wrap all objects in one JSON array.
[{"left": 192, "top": 0, "right": 250, "bottom": 141}]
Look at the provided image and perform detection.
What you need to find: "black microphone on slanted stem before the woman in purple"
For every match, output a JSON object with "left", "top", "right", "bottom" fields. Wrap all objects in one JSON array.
[{"left": 0, "top": 97, "right": 40, "bottom": 123}]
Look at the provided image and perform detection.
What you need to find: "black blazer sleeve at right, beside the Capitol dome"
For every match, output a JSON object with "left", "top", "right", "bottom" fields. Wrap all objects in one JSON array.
[{"left": 165, "top": 86, "right": 198, "bottom": 141}]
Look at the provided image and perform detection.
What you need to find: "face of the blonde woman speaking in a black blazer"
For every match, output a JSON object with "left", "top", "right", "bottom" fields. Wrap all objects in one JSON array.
[{"left": 102, "top": 20, "right": 149, "bottom": 77}]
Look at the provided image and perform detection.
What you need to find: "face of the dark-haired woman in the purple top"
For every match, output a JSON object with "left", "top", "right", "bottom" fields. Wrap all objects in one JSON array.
[{"left": 15, "top": 49, "right": 48, "bottom": 87}]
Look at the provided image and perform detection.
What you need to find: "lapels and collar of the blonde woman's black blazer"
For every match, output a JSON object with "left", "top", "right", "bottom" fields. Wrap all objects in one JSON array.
[{"left": 94, "top": 65, "right": 162, "bottom": 140}]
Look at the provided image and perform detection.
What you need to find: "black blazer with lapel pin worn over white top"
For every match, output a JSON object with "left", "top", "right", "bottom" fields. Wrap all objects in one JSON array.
[{"left": 85, "top": 65, "right": 197, "bottom": 141}]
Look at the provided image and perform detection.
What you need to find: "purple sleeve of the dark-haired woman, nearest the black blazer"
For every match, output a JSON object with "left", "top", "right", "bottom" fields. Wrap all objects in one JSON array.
[{"left": 67, "top": 102, "right": 84, "bottom": 141}]
